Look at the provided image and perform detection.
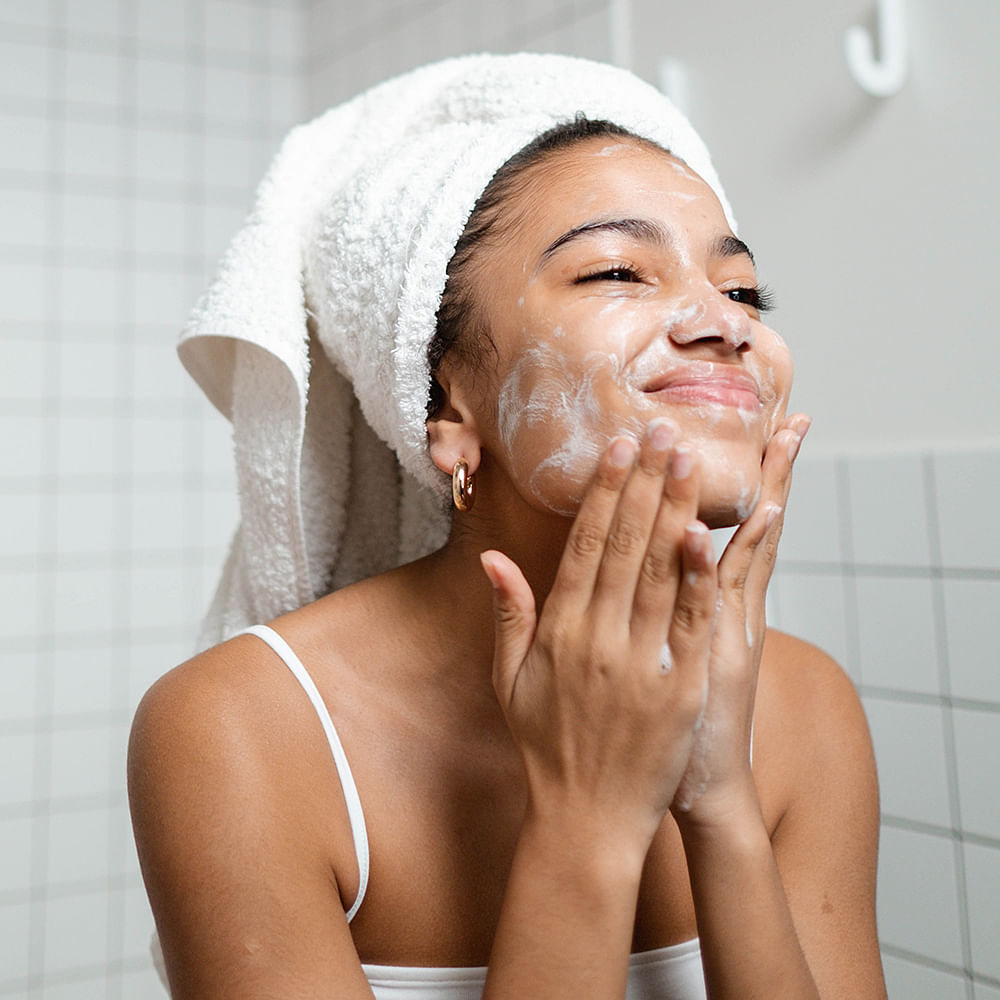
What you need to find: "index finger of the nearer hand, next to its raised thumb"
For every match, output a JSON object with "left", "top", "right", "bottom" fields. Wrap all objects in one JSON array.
[{"left": 546, "top": 436, "right": 639, "bottom": 607}]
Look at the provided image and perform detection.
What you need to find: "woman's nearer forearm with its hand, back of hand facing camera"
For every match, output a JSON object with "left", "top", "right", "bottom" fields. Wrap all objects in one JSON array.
[{"left": 483, "top": 425, "right": 716, "bottom": 1000}]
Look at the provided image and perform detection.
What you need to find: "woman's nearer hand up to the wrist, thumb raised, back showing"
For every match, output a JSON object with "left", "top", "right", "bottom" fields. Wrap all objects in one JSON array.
[{"left": 482, "top": 420, "right": 716, "bottom": 859}]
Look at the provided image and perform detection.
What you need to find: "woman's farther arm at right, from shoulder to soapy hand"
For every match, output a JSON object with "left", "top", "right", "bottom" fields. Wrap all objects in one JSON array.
[{"left": 672, "top": 418, "right": 885, "bottom": 1000}]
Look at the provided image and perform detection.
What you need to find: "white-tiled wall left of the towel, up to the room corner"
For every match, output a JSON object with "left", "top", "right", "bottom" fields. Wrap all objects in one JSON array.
[{"left": 0, "top": 0, "right": 305, "bottom": 1000}]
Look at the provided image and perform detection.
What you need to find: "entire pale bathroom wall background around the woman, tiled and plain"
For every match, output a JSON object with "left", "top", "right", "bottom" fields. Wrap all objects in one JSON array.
[{"left": 0, "top": 0, "right": 1000, "bottom": 1000}]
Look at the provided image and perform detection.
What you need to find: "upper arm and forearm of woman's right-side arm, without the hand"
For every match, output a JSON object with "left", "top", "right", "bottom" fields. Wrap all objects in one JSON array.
[{"left": 680, "top": 633, "right": 885, "bottom": 1000}]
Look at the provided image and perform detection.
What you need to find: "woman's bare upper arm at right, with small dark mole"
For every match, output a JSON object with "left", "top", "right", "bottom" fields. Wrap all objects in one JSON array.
[{"left": 757, "top": 633, "right": 885, "bottom": 997}]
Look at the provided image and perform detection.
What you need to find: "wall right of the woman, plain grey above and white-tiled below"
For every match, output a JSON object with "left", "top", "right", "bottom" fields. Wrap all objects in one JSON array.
[{"left": 630, "top": 0, "right": 1000, "bottom": 1000}]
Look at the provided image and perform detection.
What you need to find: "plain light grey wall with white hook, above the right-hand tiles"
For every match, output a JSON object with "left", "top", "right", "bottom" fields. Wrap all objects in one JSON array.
[{"left": 633, "top": 0, "right": 1000, "bottom": 453}]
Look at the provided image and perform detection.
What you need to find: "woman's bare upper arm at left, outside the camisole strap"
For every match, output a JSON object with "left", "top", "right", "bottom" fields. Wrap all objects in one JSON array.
[{"left": 128, "top": 651, "right": 371, "bottom": 1000}]
